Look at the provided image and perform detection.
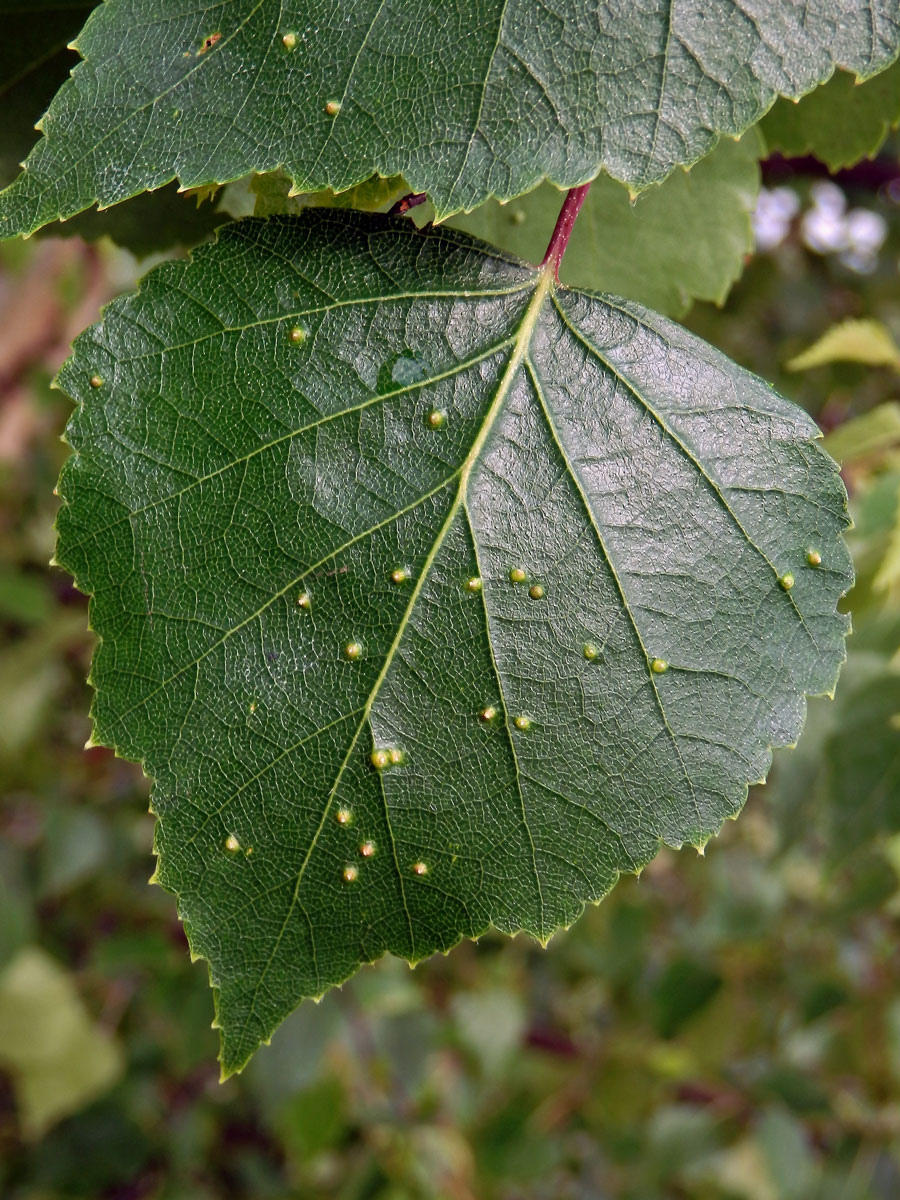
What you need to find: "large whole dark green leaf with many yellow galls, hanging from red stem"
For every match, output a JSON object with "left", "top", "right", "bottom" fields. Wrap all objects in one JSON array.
[{"left": 58, "top": 209, "right": 851, "bottom": 1073}]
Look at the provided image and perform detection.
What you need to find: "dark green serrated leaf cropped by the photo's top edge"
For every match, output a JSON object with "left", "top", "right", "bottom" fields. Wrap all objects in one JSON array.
[{"left": 0, "top": 0, "right": 900, "bottom": 236}]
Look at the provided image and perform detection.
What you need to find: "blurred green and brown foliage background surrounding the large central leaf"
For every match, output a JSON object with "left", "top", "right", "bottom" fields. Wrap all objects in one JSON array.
[{"left": 0, "top": 154, "right": 900, "bottom": 1200}]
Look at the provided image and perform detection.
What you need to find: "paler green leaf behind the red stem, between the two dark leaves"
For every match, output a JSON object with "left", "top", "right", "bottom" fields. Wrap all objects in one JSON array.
[{"left": 451, "top": 132, "right": 762, "bottom": 317}]
